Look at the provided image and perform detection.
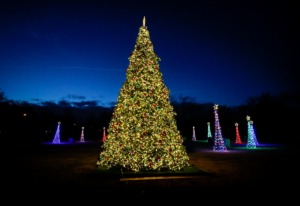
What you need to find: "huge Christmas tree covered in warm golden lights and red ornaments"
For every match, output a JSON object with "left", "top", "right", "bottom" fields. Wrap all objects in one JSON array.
[{"left": 97, "top": 17, "right": 189, "bottom": 172}]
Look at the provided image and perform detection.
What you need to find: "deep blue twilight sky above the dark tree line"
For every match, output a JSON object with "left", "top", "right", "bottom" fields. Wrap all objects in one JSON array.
[{"left": 0, "top": 0, "right": 298, "bottom": 106}]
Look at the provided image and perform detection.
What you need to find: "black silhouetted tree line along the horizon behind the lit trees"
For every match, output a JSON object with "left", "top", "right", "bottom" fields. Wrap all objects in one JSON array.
[{"left": 0, "top": 91, "right": 300, "bottom": 145}]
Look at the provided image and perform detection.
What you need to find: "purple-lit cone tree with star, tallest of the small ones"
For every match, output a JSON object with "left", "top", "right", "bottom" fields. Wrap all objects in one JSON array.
[{"left": 213, "top": 104, "right": 227, "bottom": 152}]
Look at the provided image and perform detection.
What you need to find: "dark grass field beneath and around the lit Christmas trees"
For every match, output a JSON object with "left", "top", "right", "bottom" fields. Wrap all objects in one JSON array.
[{"left": 2, "top": 142, "right": 299, "bottom": 204}]
